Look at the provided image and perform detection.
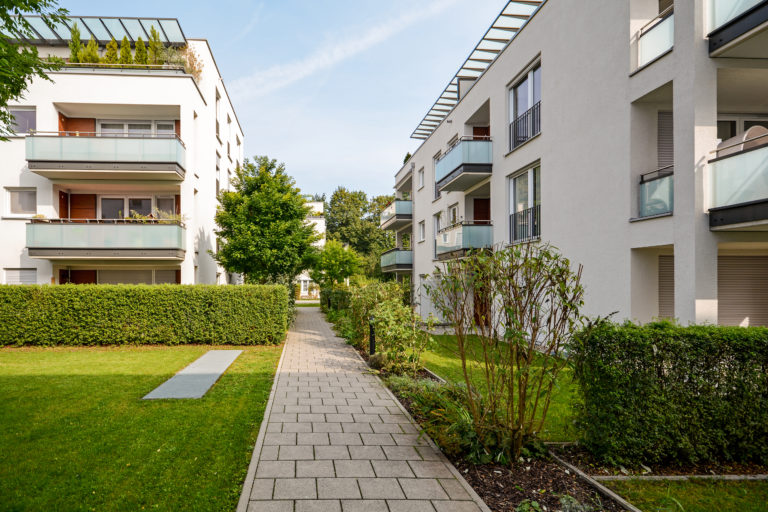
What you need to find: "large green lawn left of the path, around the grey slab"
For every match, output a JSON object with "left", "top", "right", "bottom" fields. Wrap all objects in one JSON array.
[{"left": 0, "top": 346, "right": 281, "bottom": 511}]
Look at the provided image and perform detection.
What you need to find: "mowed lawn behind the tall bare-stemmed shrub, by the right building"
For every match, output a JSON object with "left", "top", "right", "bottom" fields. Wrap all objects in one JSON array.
[{"left": 422, "top": 335, "right": 579, "bottom": 441}]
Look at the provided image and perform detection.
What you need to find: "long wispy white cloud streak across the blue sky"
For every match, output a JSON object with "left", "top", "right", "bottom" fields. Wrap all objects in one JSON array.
[{"left": 230, "top": 0, "right": 457, "bottom": 99}]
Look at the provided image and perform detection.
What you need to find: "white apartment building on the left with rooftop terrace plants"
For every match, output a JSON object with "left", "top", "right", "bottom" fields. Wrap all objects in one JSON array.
[{"left": 0, "top": 17, "right": 243, "bottom": 284}]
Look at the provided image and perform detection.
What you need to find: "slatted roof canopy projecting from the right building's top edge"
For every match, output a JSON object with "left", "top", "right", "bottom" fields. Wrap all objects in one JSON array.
[{"left": 411, "top": 0, "right": 546, "bottom": 139}]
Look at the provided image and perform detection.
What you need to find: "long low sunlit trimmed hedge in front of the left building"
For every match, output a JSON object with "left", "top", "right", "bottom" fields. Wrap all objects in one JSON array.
[{"left": 0, "top": 285, "right": 291, "bottom": 346}]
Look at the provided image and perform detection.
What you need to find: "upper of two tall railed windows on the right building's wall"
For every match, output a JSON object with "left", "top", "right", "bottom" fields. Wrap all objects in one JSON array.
[{"left": 509, "top": 65, "right": 541, "bottom": 151}]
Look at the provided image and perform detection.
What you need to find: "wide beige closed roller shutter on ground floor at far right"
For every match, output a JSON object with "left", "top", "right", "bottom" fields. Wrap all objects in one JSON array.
[{"left": 717, "top": 256, "right": 768, "bottom": 327}]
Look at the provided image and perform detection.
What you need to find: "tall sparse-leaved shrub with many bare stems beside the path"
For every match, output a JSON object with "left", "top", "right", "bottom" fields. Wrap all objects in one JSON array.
[{"left": 427, "top": 243, "right": 584, "bottom": 462}]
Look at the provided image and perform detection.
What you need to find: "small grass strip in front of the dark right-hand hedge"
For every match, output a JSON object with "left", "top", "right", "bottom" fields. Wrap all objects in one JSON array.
[{"left": 604, "top": 480, "right": 768, "bottom": 512}]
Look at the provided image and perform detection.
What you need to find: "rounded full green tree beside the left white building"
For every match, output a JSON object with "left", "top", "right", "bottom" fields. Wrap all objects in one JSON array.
[{"left": 214, "top": 156, "right": 318, "bottom": 283}]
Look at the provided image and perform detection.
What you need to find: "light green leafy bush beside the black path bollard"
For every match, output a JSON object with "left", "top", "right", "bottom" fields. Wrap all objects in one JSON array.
[{"left": 373, "top": 297, "right": 433, "bottom": 375}]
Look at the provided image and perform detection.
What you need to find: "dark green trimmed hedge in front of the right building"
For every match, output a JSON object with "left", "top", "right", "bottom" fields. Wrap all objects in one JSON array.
[{"left": 572, "top": 322, "right": 768, "bottom": 466}]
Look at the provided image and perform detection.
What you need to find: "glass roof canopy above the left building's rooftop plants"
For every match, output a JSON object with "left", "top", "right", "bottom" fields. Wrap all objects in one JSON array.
[{"left": 16, "top": 16, "right": 187, "bottom": 46}]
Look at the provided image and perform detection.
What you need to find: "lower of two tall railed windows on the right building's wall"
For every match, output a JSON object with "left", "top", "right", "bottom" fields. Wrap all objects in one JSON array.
[{"left": 509, "top": 166, "right": 541, "bottom": 242}]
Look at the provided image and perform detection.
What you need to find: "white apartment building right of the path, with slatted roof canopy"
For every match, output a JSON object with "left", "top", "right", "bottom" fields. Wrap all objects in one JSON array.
[{"left": 382, "top": 0, "right": 768, "bottom": 326}]
